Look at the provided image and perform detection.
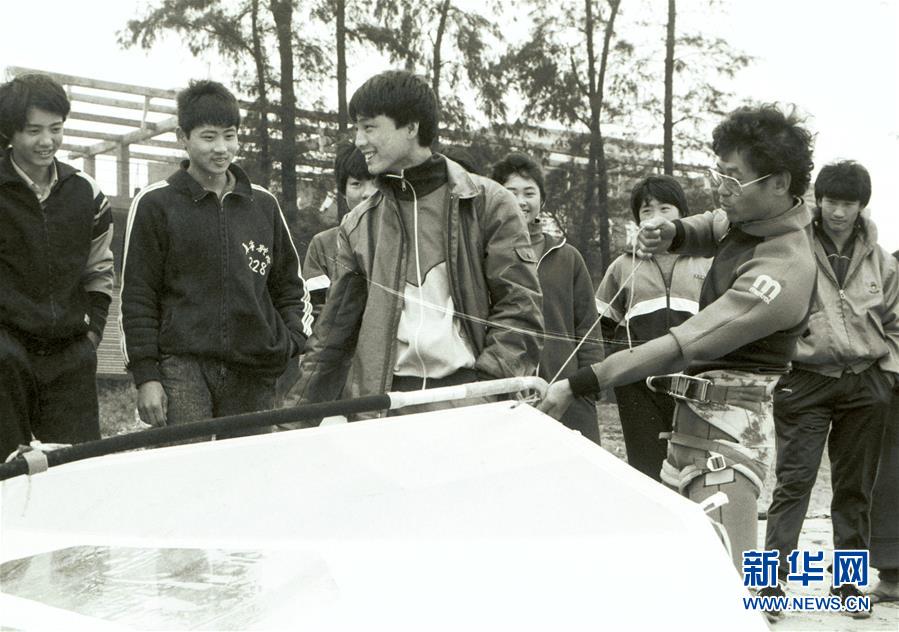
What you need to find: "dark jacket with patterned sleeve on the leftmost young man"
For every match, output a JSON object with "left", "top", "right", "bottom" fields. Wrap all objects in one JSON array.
[{"left": 0, "top": 155, "right": 115, "bottom": 342}]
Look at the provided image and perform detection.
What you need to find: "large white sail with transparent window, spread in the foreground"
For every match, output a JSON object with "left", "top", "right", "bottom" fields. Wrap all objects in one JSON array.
[{"left": 0, "top": 402, "right": 767, "bottom": 631}]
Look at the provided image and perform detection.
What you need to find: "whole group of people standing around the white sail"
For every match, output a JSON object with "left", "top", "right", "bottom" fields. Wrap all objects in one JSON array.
[{"left": 0, "top": 71, "right": 899, "bottom": 612}]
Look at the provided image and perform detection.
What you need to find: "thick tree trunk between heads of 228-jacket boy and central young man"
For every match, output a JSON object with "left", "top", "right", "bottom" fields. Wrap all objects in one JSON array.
[{"left": 271, "top": 0, "right": 297, "bottom": 221}]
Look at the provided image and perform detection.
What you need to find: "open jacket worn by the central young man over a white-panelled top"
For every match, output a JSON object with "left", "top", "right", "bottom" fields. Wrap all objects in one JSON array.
[{"left": 294, "top": 159, "right": 543, "bottom": 402}]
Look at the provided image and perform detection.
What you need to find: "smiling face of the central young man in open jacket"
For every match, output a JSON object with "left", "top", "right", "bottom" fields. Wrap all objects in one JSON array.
[{"left": 356, "top": 114, "right": 430, "bottom": 175}]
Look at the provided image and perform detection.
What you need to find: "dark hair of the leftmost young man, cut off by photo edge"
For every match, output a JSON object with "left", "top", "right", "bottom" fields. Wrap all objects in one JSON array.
[{"left": 0, "top": 73, "right": 70, "bottom": 148}]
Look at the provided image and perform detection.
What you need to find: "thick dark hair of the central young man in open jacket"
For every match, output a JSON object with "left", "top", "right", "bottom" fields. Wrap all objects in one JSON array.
[{"left": 349, "top": 70, "right": 439, "bottom": 147}]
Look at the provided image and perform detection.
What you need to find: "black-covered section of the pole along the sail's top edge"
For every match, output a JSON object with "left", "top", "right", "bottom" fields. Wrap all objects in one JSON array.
[{"left": 0, "top": 394, "right": 390, "bottom": 481}]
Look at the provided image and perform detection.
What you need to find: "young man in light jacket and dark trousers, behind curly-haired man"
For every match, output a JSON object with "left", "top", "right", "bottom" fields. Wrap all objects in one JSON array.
[{"left": 765, "top": 161, "right": 899, "bottom": 616}]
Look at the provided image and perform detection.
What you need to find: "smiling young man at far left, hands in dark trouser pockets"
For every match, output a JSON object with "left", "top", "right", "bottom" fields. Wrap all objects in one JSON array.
[{"left": 0, "top": 75, "right": 114, "bottom": 461}]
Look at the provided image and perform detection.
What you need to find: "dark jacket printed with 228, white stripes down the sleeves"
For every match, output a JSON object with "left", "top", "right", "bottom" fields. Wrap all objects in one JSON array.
[{"left": 121, "top": 161, "right": 312, "bottom": 386}]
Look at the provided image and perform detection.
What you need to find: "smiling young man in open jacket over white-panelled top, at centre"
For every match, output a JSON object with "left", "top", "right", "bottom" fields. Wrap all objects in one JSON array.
[{"left": 289, "top": 71, "right": 543, "bottom": 414}]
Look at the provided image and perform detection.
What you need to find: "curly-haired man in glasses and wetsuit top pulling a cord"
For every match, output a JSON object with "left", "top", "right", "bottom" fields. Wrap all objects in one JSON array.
[{"left": 540, "top": 106, "right": 815, "bottom": 584}]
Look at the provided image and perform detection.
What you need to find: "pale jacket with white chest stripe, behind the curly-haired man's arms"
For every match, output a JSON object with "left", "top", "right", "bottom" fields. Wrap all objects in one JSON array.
[{"left": 596, "top": 253, "right": 712, "bottom": 360}]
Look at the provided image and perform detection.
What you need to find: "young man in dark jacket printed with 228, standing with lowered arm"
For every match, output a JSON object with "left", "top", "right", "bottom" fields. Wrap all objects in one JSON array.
[{"left": 121, "top": 81, "right": 312, "bottom": 436}]
